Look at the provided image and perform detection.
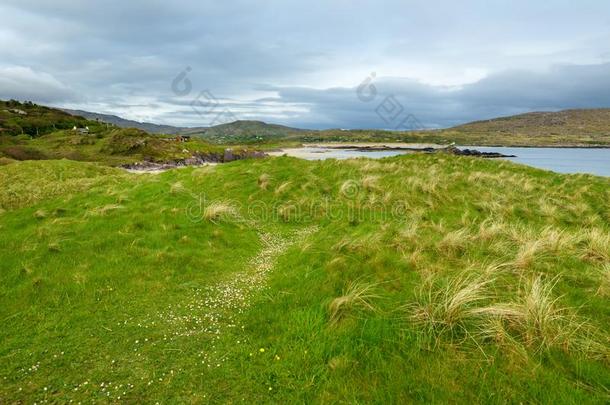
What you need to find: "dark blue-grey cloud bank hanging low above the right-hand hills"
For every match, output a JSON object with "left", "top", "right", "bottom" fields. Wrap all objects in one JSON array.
[{"left": 260, "top": 64, "right": 610, "bottom": 129}]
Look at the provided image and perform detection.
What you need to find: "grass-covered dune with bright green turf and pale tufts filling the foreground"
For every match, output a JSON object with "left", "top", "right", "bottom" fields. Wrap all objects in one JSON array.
[{"left": 0, "top": 154, "right": 610, "bottom": 403}]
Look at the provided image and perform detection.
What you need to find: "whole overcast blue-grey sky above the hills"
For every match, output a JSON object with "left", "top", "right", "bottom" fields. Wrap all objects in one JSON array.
[{"left": 0, "top": 0, "right": 610, "bottom": 129}]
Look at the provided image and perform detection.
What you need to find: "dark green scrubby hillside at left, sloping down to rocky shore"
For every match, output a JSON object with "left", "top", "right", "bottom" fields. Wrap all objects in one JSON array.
[{"left": 0, "top": 101, "right": 254, "bottom": 166}]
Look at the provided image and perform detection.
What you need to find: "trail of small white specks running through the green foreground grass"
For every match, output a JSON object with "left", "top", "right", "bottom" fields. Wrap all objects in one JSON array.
[{"left": 59, "top": 226, "right": 317, "bottom": 402}]
